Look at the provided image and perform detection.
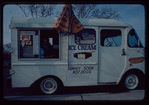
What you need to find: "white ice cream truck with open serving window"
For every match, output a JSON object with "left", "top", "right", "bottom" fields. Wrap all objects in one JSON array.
[{"left": 9, "top": 17, "right": 145, "bottom": 94}]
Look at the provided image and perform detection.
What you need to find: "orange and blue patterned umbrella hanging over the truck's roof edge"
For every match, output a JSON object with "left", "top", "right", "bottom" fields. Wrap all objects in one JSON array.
[{"left": 53, "top": 4, "right": 84, "bottom": 33}]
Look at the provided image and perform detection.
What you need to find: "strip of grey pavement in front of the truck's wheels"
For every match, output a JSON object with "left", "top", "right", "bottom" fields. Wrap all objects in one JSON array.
[{"left": 4, "top": 90, "right": 145, "bottom": 100}]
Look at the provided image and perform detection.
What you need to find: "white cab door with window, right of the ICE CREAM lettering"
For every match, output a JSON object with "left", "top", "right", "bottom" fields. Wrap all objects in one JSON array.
[{"left": 98, "top": 27, "right": 126, "bottom": 83}]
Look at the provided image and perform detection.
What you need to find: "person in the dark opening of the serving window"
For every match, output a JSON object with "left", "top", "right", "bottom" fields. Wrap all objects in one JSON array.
[{"left": 40, "top": 38, "right": 54, "bottom": 58}]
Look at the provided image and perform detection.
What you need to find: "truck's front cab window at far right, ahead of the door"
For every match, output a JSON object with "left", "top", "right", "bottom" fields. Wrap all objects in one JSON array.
[{"left": 128, "top": 29, "right": 143, "bottom": 48}]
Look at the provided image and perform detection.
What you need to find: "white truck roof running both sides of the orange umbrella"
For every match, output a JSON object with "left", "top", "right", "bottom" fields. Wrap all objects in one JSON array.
[{"left": 10, "top": 17, "right": 132, "bottom": 28}]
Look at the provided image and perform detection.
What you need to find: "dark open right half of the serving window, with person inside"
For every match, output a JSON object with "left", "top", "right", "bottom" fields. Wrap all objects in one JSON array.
[{"left": 40, "top": 30, "right": 59, "bottom": 59}]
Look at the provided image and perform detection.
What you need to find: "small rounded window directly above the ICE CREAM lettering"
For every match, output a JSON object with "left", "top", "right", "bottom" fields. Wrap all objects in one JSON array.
[{"left": 75, "top": 29, "right": 96, "bottom": 45}]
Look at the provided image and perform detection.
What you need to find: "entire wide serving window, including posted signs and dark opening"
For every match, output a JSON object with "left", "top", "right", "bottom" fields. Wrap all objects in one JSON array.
[{"left": 19, "top": 29, "right": 59, "bottom": 59}]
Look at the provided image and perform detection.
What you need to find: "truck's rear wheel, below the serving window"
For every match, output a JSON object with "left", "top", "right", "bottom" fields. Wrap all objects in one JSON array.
[{"left": 40, "top": 77, "right": 58, "bottom": 94}]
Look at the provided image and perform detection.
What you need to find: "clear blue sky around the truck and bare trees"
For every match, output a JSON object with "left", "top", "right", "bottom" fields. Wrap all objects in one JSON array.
[{"left": 3, "top": 4, "right": 145, "bottom": 46}]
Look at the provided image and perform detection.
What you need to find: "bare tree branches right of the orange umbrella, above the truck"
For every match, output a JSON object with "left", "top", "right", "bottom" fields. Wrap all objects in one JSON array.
[{"left": 73, "top": 4, "right": 121, "bottom": 19}]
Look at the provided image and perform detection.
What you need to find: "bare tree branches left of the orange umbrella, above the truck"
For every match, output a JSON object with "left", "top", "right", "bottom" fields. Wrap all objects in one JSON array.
[{"left": 18, "top": 4, "right": 56, "bottom": 17}]
